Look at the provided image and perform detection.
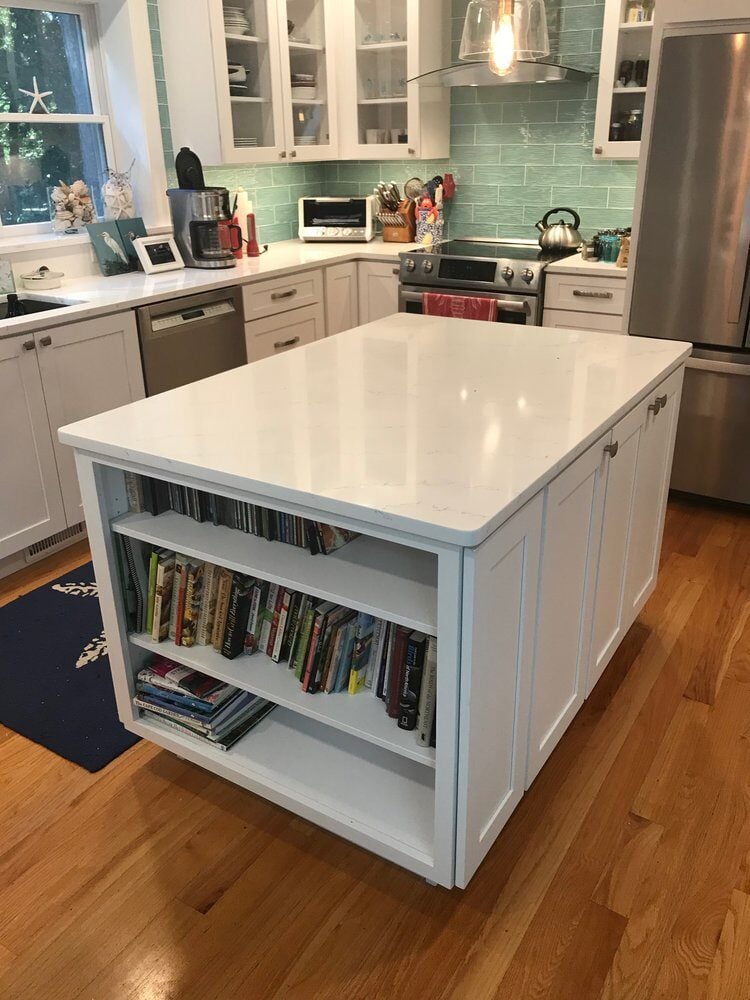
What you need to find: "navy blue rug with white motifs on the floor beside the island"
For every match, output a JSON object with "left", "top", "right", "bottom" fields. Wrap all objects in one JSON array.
[{"left": 0, "top": 563, "right": 138, "bottom": 771}]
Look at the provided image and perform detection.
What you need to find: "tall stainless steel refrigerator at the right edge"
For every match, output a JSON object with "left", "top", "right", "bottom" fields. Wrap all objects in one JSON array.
[{"left": 629, "top": 23, "right": 750, "bottom": 504}]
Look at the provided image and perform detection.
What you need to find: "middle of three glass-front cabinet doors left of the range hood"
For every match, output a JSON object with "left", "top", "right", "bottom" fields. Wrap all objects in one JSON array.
[{"left": 279, "top": 0, "right": 341, "bottom": 161}]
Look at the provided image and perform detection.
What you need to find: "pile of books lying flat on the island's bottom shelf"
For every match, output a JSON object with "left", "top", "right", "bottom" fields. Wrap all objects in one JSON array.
[{"left": 133, "top": 656, "right": 276, "bottom": 750}]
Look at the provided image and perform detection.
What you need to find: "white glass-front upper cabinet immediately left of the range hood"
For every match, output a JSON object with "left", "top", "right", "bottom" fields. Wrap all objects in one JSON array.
[{"left": 340, "top": 0, "right": 450, "bottom": 160}]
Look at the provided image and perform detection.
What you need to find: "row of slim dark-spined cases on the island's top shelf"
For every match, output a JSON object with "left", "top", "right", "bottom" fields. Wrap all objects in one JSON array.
[{"left": 125, "top": 472, "right": 357, "bottom": 555}]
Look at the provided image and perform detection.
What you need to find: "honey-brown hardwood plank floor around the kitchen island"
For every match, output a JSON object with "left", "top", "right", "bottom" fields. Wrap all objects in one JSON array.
[{"left": 0, "top": 500, "right": 750, "bottom": 1000}]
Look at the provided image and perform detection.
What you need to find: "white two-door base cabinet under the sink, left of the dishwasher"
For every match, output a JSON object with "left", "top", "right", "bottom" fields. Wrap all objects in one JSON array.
[{"left": 0, "top": 312, "right": 144, "bottom": 558}]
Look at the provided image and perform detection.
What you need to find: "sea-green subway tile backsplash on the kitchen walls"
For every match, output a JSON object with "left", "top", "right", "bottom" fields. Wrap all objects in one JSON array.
[{"left": 148, "top": 0, "right": 637, "bottom": 243}]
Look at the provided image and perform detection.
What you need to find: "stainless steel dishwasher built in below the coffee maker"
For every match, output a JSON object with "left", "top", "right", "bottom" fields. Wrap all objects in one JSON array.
[{"left": 137, "top": 288, "right": 247, "bottom": 396}]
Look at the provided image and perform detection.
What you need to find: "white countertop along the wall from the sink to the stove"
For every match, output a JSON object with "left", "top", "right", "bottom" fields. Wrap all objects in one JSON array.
[{"left": 0, "top": 240, "right": 416, "bottom": 339}]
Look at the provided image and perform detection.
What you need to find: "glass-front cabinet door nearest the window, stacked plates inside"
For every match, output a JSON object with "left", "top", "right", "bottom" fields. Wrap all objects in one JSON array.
[{"left": 217, "top": 0, "right": 286, "bottom": 163}]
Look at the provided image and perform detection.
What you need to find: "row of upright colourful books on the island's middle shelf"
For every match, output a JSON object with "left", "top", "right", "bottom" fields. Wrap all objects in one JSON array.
[{"left": 115, "top": 534, "right": 437, "bottom": 746}]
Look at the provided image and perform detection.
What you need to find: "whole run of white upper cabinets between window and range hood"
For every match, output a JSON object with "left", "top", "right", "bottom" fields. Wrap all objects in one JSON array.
[{"left": 159, "top": 0, "right": 450, "bottom": 165}]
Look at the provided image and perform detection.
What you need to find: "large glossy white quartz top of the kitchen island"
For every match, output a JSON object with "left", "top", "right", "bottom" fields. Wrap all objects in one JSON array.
[{"left": 59, "top": 313, "right": 691, "bottom": 546}]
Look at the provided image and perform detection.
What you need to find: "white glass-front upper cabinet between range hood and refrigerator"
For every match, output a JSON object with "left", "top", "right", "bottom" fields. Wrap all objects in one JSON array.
[{"left": 594, "top": 0, "right": 654, "bottom": 160}]
